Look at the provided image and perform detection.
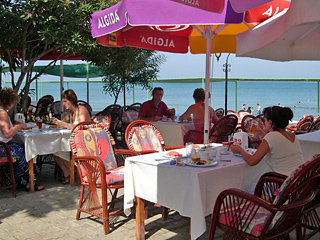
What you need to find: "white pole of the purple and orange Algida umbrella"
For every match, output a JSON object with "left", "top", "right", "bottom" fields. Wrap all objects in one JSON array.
[{"left": 203, "top": 26, "right": 212, "bottom": 144}]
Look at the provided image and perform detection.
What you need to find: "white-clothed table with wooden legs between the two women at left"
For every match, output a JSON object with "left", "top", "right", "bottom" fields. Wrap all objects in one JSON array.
[{"left": 13, "top": 126, "right": 75, "bottom": 192}]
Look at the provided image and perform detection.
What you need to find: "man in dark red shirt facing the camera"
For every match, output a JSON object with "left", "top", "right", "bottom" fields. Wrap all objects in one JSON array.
[{"left": 139, "top": 87, "right": 175, "bottom": 121}]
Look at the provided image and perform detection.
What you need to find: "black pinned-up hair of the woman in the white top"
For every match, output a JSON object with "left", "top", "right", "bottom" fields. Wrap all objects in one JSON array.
[{"left": 263, "top": 106, "right": 293, "bottom": 130}]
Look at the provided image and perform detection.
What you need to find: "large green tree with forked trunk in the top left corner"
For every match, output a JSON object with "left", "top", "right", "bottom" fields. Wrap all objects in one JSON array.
[{"left": 0, "top": 0, "right": 111, "bottom": 110}]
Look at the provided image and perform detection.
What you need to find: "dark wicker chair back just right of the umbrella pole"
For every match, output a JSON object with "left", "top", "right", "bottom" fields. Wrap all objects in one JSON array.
[{"left": 209, "top": 114, "right": 238, "bottom": 143}]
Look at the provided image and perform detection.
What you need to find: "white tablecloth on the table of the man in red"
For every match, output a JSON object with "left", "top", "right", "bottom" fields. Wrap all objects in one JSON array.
[{"left": 152, "top": 121, "right": 195, "bottom": 146}]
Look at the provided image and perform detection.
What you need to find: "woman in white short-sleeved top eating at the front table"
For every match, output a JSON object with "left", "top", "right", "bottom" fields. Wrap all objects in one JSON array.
[{"left": 231, "top": 106, "right": 304, "bottom": 175}]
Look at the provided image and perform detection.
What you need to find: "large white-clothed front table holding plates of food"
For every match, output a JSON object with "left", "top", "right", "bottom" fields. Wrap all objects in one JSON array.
[{"left": 124, "top": 143, "right": 271, "bottom": 240}]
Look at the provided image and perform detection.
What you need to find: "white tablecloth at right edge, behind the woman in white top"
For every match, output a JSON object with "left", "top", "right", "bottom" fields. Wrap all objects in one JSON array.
[{"left": 297, "top": 131, "right": 320, "bottom": 161}]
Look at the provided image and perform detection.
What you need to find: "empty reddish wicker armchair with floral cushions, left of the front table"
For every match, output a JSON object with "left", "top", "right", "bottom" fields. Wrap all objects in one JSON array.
[{"left": 70, "top": 122, "right": 136, "bottom": 234}]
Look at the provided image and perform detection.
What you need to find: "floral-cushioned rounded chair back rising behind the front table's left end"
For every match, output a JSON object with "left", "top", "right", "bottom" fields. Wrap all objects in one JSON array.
[{"left": 125, "top": 120, "right": 164, "bottom": 152}]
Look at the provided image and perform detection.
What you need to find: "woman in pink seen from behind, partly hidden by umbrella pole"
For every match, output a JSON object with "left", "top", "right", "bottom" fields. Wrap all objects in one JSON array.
[{"left": 179, "top": 88, "right": 218, "bottom": 131}]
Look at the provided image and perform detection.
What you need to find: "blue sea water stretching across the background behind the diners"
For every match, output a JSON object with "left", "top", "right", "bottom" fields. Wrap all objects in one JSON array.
[{"left": 6, "top": 81, "right": 318, "bottom": 120}]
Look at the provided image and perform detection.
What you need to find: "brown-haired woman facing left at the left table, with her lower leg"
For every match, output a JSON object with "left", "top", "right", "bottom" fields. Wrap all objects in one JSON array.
[{"left": 52, "top": 89, "right": 91, "bottom": 184}]
